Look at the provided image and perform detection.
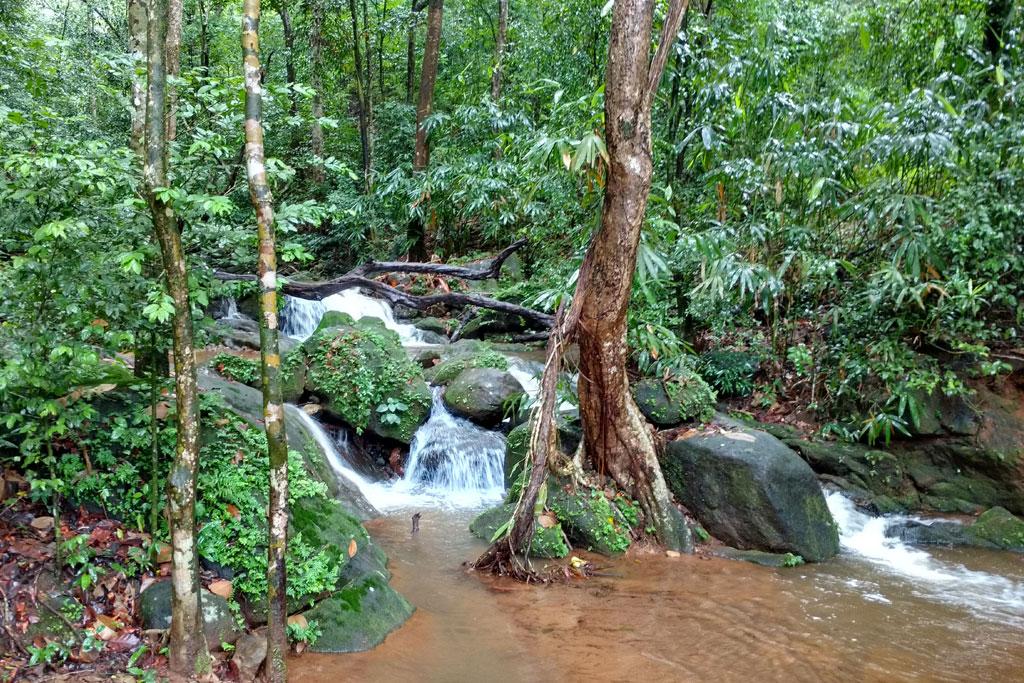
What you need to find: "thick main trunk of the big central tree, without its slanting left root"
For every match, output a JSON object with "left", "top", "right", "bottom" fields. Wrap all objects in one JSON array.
[{"left": 570, "top": 0, "right": 691, "bottom": 549}]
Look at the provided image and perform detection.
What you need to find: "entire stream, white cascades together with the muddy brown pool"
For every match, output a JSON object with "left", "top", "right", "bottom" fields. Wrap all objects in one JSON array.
[{"left": 283, "top": 290, "right": 1024, "bottom": 682}]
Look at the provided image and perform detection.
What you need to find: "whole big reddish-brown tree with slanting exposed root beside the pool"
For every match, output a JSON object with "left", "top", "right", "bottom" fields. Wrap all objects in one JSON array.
[{"left": 476, "top": 0, "right": 692, "bottom": 577}]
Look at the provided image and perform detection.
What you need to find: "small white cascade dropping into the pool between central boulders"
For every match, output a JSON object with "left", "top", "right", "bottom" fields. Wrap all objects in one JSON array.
[{"left": 403, "top": 387, "right": 505, "bottom": 500}]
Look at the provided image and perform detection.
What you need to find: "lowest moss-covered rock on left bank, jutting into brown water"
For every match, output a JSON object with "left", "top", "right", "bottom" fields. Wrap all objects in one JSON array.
[{"left": 305, "top": 573, "right": 414, "bottom": 652}]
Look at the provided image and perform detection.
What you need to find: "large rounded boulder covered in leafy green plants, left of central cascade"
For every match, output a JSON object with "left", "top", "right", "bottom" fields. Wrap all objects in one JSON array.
[{"left": 306, "top": 316, "right": 430, "bottom": 443}]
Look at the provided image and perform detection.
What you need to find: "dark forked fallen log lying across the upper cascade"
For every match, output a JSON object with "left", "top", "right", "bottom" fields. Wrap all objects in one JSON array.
[{"left": 214, "top": 240, "right": 555, "bottom": 330}]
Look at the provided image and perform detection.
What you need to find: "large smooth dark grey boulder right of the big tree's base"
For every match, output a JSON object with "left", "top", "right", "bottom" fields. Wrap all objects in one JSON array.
[{"left": 663, "top": 418, "right": 839, "bottom": 562}]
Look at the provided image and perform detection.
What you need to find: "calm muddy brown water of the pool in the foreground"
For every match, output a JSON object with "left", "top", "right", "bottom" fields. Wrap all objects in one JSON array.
[{"left": 289, "top": 509, "right": 1024, "bottom": 683}]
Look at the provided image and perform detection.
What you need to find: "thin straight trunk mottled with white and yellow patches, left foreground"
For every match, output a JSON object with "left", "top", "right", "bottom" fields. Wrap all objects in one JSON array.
[{"left": 242, "top": 0, "right": 288, "bottom": 683}]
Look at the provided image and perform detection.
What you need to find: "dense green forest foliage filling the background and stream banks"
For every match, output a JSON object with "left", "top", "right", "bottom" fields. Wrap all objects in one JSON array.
[{"left": 0, "top": 0, "right": 1024, "bottom": 679}]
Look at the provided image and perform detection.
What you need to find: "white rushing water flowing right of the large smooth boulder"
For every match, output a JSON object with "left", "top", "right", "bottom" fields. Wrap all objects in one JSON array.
[{"left": 825, "top": 493, "right": 1024, "bottom": 625}]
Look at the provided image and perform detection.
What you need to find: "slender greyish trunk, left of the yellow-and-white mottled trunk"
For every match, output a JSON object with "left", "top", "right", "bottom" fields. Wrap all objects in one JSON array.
[{"left": 142, "top": 0, "right": 210, "bottom": 677}]
